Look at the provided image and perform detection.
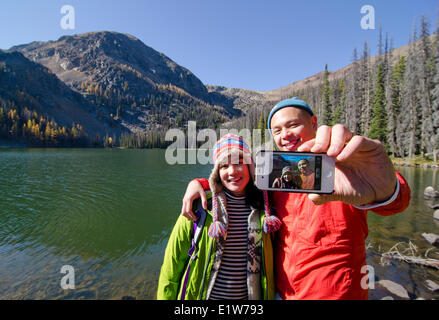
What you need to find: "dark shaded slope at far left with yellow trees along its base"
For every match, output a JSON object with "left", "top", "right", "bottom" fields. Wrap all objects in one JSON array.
[{"left": 0, "top": 50, "right": 121, "bottom": 146}]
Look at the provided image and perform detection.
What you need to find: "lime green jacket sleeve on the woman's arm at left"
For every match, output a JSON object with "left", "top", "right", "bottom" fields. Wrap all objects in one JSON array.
[{"left": 157, "top": 215, "right": 193, "bottom": 300}]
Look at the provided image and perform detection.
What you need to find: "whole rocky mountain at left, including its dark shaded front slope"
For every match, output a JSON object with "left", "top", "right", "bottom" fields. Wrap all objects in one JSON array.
[{"left": 0, "top": 31, "right": 241, "bottom": 147}]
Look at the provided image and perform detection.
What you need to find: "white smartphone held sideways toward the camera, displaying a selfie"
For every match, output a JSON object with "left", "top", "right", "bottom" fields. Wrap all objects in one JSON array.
[{"left": 255, "top": 150, "right": 335, "bottom": 194}]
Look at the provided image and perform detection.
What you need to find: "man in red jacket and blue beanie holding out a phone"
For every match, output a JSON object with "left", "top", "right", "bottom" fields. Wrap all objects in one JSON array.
[{"left": 182, "top": 98, "right": 410, "bottom": 299}]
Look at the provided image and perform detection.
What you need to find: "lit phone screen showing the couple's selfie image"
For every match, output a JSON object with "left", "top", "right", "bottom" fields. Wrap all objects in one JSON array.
[{"left": 269, "top": 154, "right": 322, "bottom": 191}]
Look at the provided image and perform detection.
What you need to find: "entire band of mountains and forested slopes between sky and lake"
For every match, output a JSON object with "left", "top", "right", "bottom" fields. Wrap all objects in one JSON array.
[{"left": 0, "top": 17, "right": 439, "bottom": 157}]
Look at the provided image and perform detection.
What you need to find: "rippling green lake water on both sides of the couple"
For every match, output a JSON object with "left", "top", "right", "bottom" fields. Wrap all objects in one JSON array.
[{"left": 0, "top": 149, "right": 439, "bottom": 299}]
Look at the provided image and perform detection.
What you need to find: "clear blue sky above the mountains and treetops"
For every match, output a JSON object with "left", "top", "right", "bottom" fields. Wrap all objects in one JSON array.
[{"left": 0, "top": 0, "right": 439, "bottom": 91}]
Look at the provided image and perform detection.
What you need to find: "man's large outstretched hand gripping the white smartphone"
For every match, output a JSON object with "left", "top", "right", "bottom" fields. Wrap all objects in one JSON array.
[{"left": 298, "top": 125, "right": 397, "bottom": 205}]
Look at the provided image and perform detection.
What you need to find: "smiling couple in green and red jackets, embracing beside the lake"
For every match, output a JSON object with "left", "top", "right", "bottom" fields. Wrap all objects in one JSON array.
[{"left": 157, "top": 98, "right": 410, "bottom": 300}]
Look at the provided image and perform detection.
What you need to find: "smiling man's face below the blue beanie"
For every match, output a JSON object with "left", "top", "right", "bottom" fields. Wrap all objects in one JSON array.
[{"left": 271, "top": 107, "right": 317, "bottom": 151}]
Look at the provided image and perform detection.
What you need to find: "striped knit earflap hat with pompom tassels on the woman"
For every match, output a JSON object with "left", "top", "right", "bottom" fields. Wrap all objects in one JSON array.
[{"left": 208, "top": 133, "right": 281, "bottom": 238}]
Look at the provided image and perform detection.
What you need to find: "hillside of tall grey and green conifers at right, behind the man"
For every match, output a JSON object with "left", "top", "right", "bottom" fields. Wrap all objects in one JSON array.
[{"left": 227, "top": 17, "right": 439, "bottom": 157}]
